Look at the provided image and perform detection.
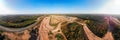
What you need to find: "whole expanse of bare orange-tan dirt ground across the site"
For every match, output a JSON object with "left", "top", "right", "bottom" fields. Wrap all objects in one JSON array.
[{"left": 2, "top": 15, "right": 118, "bottom": 40}]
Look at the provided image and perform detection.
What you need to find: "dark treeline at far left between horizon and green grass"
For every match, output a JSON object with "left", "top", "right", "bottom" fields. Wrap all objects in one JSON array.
[{"left": 0, "top": 15, "right": 37, "bottom": 23}]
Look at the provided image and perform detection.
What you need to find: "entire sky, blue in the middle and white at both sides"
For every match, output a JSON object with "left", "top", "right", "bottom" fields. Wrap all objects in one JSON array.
[{"left": 0, "top": 0, "right": 120, "bottom": 15}]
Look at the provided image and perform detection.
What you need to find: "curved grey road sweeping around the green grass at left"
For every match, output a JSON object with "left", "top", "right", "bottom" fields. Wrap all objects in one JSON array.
[{"left": 0, "top": 17, "right": 41, "bottom": 32}]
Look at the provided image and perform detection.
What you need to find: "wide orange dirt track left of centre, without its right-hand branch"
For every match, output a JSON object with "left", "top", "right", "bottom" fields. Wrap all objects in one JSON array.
[{"left": 38, "top": 17, "right": 53, "bottom": 40}]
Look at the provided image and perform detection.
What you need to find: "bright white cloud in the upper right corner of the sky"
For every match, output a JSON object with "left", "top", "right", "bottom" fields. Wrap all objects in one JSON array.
[{"left": 98, "top": 0, "right": 120, "bottom": 15}]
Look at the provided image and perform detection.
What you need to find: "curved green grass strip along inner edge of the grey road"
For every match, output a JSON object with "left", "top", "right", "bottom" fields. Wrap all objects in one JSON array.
[{"left": 0, "top": 20, "right": 35, "bottom": 28}]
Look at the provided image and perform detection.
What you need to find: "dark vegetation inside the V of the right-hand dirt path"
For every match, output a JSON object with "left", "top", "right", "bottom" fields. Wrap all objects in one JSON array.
[{"left": 87, "top": 20, "right": 107, "bottom": 38}]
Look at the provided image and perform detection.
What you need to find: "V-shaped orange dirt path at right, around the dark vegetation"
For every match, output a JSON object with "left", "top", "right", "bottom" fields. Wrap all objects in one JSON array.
[{"left": 79, "top": 24, "right": 114, "bottom": 40}]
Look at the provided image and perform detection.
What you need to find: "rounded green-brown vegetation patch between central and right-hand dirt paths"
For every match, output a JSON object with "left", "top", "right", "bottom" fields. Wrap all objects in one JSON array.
[{"left": 62, "top": 23, "right": 87, "bottom": 40}]
